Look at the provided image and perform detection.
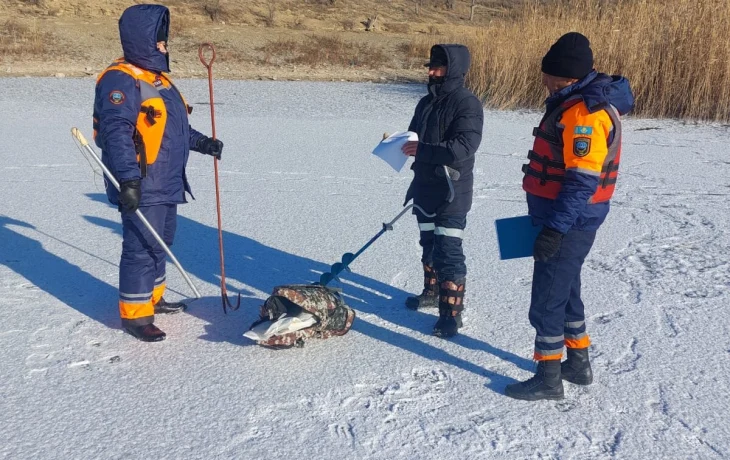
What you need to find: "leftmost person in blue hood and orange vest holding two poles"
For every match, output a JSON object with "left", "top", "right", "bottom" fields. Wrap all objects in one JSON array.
[{"left": 94, "top": 5, "right": 223, "bottom": 342}]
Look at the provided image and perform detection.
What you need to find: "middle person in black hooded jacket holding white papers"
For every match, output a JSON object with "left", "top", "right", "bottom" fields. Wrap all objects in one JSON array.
[{"left": 403, "top": 45, "right": 484, "bottom": 337}]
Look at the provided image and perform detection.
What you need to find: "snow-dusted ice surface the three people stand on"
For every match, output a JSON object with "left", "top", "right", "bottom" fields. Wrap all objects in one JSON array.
[{"left": 0, "top": 78, "right": 730, "bottom": 459}]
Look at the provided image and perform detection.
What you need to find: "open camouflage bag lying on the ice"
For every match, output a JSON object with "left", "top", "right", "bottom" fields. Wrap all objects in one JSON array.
[{"left": 244, "top": 284, "right": 355, "bottom": 348}]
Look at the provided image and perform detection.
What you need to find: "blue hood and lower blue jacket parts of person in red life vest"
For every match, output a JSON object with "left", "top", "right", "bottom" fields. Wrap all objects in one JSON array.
[{"left": 527, "top": 71, "right": 634, "bottom": 234}]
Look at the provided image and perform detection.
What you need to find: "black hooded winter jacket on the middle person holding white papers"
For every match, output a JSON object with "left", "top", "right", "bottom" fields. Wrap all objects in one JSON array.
[{"left": 406, "top": 45, "right": 484, "bottom": 214}]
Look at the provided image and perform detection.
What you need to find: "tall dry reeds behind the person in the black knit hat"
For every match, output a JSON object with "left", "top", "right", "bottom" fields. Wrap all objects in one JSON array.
[{"left": 450, "top": 0, "right": 730, "bottom": 121}]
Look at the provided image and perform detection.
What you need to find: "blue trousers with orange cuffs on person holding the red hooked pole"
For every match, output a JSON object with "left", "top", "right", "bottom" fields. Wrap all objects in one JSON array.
[{"left": 119, "top": 205, "right": 177, "bottom": 326}]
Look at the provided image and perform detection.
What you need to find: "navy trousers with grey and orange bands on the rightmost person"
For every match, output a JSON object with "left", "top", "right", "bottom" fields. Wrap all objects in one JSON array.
[{"left": 530, "top": 230, "right": 596, "bottom": 361}]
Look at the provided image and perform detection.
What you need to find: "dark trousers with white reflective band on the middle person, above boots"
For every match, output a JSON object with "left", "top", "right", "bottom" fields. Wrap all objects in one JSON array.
[{"left": 416, "top": 213, "right": 466, "bottom": 282}]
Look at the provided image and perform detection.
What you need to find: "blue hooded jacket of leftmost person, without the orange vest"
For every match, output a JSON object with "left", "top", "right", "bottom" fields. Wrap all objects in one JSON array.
[{"left": 94, "top": 5, "right": 204, "bottom": 206}]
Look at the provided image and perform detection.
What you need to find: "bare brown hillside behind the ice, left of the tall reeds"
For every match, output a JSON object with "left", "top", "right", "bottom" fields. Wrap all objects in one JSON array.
[{"left": 0, "top": 0, "right": 506, "bottom": 81}]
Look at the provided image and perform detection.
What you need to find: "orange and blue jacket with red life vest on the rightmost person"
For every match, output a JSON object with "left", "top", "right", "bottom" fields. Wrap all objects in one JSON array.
[{"left": 522, "top": 72, "right": 634, "bottom": 233}]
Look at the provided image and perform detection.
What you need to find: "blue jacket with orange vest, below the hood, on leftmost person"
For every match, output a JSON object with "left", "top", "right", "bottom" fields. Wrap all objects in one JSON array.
[{"left": 94, "top": 59, "right": 202, "bottom": 206}]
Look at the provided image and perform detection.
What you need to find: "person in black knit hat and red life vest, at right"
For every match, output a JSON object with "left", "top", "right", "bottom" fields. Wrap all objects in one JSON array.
[{"left": 505, "top": 32, "right": 634, "bottom": 400}]
